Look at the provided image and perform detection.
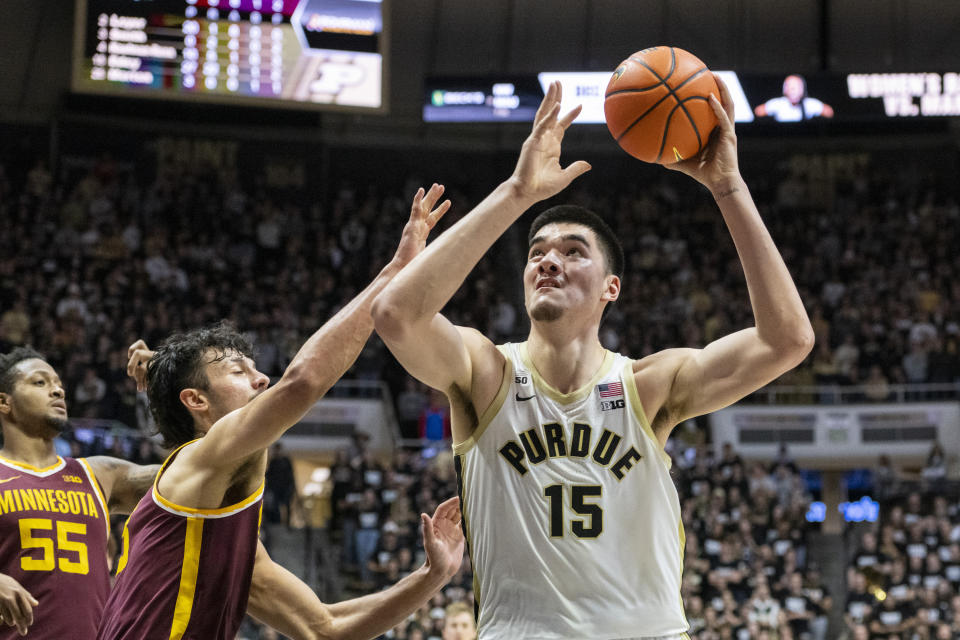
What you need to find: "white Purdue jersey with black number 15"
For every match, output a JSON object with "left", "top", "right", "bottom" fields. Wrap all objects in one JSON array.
[{"left": 454, "top": 343, "right": 688, "bottom": 640}]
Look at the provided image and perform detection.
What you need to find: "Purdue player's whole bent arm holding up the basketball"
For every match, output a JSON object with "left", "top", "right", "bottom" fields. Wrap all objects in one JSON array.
[{"left": 648, "top": 78, "right": 814, "bottom": 439}]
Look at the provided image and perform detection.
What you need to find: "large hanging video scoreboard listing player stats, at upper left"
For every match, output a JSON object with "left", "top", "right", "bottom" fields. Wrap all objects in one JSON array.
[{"left": 73, "top": 0, "right": 388, "bottom": 112}]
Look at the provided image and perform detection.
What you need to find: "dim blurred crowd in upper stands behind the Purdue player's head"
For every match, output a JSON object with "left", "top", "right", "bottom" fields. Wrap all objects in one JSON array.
[{"left": 0, "top": 144, "right": 960, "bottom": 436}]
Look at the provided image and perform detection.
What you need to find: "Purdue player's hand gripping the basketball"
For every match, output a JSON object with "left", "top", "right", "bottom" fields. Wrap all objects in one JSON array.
[{"left": 665, "top": 74, "right": 740, "bottom": 193}]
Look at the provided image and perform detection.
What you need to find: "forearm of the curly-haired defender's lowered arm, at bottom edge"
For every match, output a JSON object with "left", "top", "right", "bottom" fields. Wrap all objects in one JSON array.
[{"left": 328, "top": 566, "right": 447, "bottom": 640}]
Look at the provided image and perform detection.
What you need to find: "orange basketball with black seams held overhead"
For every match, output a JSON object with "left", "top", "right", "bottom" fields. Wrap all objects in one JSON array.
[{"left": 603, "top": 47, "right": 720, "bottom": 164}]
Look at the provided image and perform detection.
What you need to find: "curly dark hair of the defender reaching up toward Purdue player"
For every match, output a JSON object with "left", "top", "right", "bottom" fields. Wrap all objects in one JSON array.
[{"left": 147, "top": 321, "right": 253, "bottom": 449}]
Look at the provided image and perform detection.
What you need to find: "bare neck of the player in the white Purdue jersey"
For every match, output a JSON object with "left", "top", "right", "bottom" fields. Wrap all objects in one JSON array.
[{"left": 527, "top": 327, "right": 606, "bottom": 393}]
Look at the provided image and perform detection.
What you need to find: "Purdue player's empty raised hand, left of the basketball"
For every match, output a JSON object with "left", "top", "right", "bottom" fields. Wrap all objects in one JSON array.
[{"left": 510, "top": 82, "right": 591, "bottom": 202}]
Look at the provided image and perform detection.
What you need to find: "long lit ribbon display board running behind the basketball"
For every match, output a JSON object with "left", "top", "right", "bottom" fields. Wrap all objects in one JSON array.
[{"left": 423, "top": 71, "right": 960, "bottom": 124}]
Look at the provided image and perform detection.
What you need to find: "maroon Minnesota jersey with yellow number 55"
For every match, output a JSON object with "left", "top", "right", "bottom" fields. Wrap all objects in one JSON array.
[{"left": 0, "top": 456, "right": 110, "bottom": 640}]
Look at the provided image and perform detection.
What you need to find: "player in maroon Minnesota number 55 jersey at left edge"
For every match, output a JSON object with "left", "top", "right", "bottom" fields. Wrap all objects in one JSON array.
[{"left": 0, "top": 347, "right": 159, "bottom": 640}]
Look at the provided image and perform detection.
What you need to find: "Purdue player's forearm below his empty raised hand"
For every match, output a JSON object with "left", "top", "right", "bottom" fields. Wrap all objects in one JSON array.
[{"left": 374, "top": 180, "right": 533, "bottom": 330}]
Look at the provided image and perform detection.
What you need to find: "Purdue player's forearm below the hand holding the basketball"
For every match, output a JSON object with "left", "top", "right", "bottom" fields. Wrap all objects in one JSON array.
[{"left": 712, "top": 176, "right": 812, "bottom": 348}]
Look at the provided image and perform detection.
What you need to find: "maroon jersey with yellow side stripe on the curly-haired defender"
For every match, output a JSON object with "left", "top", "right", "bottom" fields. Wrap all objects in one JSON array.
[{"left": 97, "top": 443, "right": 263, "bottom": 640}]
